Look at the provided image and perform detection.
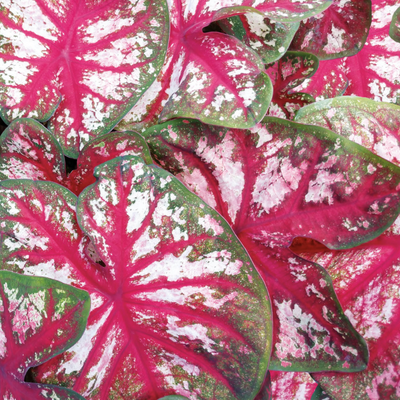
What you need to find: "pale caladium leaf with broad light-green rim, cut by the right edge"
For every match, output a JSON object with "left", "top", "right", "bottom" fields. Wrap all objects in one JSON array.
[{"left": 296, "top": 96, "right": 400, "bottom": 165}]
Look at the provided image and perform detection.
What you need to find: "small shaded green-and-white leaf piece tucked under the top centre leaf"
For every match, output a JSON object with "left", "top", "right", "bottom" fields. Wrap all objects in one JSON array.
[{"left": 218, "top": 12, "right": 299, "bottom": 64}]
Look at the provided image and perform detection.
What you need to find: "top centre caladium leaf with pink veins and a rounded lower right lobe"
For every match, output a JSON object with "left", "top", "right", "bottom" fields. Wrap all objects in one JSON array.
[{"left": 115, "top": 0, "right": 331, "bottom": 130}]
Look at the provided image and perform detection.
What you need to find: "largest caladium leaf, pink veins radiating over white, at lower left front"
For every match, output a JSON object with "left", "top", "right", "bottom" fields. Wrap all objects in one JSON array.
[{"left": 0, "top": 161, "right": 272, "bottom": 400}]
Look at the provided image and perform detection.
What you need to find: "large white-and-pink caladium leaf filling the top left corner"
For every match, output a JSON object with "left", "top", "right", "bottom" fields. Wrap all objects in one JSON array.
[{"left": 0, "top": 0, "right": 169, "bottom": 157}]
